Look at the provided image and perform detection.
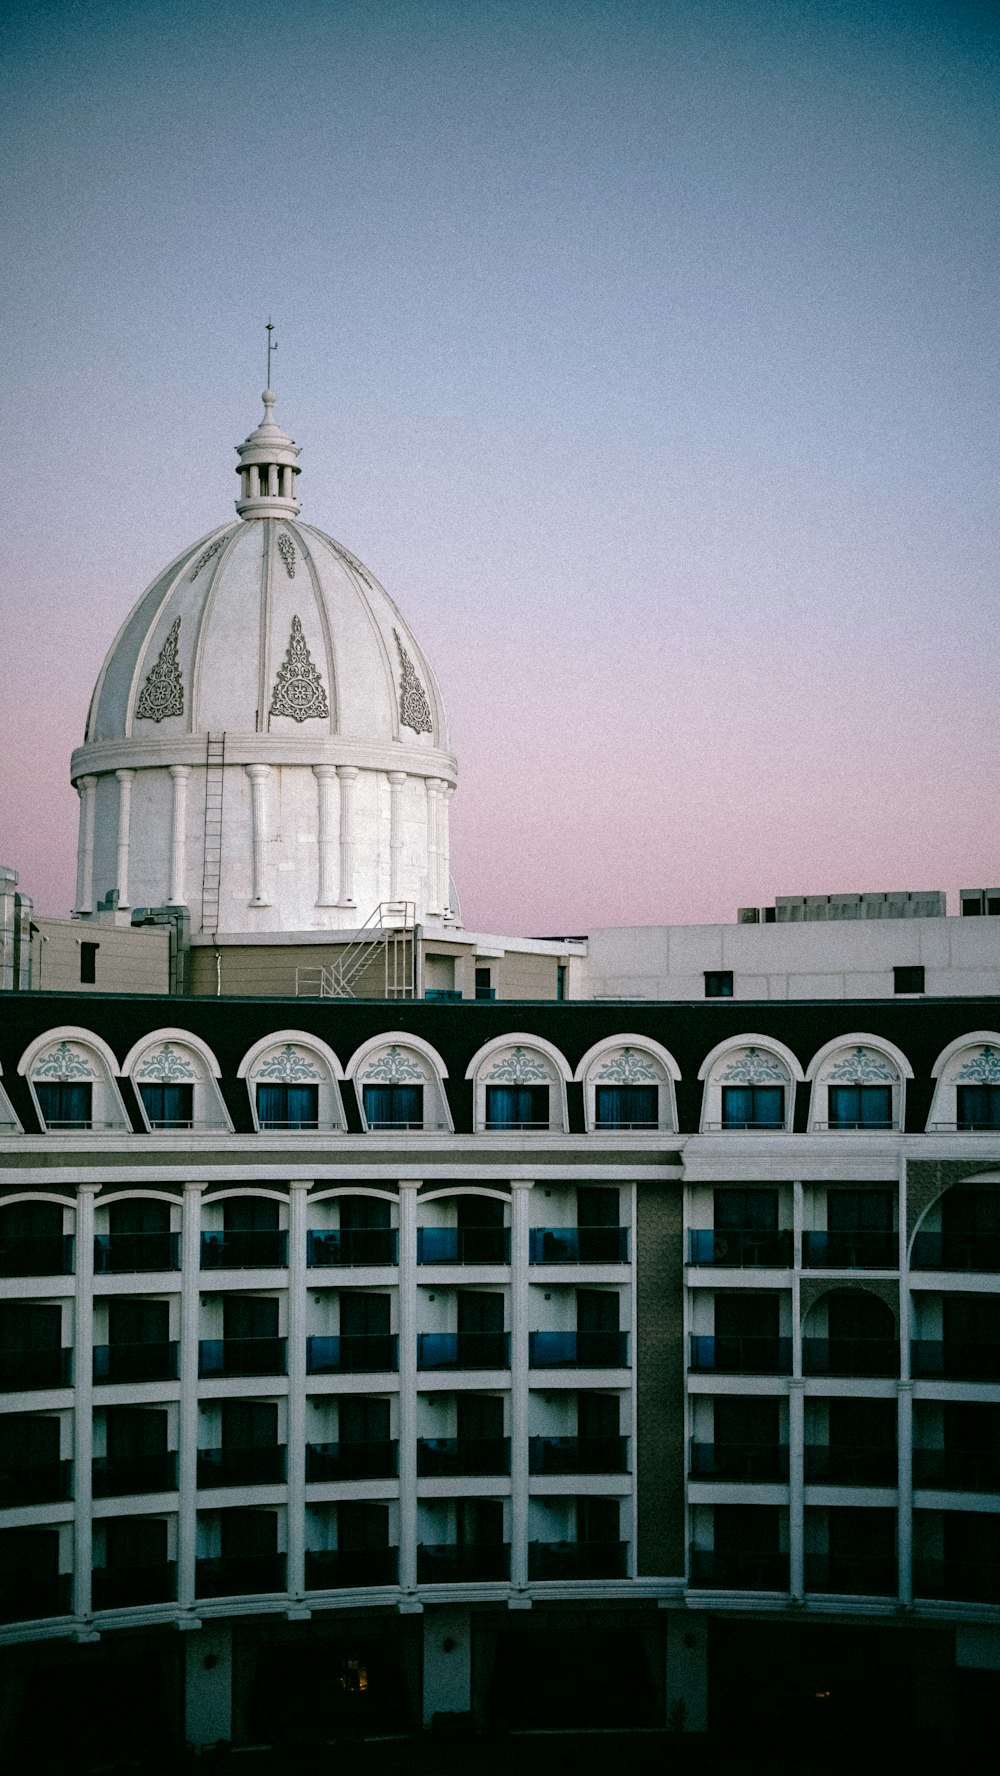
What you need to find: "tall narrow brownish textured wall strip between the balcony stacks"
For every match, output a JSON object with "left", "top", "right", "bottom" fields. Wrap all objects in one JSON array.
[{"left": 632, "top": 1181, "right": 686, "bottom": 1579}]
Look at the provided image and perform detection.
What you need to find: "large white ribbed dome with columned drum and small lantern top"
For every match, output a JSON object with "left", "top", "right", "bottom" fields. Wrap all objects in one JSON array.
[{"left": 71, "top": 391, "right": 456, "bottom": 932}]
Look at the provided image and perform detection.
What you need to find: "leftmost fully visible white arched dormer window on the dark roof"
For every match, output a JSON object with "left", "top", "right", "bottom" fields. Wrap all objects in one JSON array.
[{"left": 18, "top": 1027, "right": 131, "bottom": 1135}]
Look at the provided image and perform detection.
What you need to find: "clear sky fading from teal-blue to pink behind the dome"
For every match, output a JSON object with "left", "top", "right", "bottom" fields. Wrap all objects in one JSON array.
[{"left": 0, "top": 0, "right": 1000, "bottom": 932}]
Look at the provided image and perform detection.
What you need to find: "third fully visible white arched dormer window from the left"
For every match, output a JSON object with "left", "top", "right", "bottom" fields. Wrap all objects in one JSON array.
[{"left": 236, "top": 1030, "right": 346, "bottom": 1135}]
